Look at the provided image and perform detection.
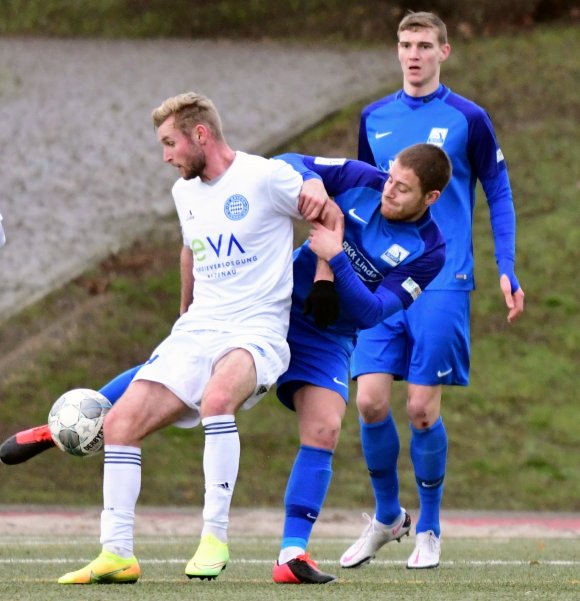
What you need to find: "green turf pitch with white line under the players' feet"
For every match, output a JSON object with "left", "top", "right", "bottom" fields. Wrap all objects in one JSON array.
[{"left": 0, "top": 536, "right": 580, "bottom": 601}]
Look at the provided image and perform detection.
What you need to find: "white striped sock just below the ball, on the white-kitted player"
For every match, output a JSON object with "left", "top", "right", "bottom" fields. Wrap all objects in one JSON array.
[{"left": 101, "top": 445, "right": 141, "bottom": 558}]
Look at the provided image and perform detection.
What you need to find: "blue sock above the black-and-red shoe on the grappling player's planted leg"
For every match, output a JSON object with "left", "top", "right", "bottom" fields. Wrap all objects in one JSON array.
[{"left": 282, "top": 445, "right": 334, "bottom": 549}]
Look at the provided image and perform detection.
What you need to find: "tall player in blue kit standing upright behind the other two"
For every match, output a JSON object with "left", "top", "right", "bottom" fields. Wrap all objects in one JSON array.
[{"left": 340, "top": 12, "right": 524, "bottom": 569}]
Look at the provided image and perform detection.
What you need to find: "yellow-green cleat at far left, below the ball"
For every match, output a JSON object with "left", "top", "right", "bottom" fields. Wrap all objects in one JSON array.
[{"left": 58, "top": 551, "right": 141, "bottom": 584}]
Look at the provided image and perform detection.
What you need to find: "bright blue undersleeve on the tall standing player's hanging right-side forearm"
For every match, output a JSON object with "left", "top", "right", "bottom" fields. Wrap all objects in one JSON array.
[{"left": 481, "top": 169, "right": 520, "bottom": 293}]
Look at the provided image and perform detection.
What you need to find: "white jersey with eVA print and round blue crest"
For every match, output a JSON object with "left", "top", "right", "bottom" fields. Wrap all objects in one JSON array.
[{"left": 173, "top": 151, "right": 302, "bottom": 338}]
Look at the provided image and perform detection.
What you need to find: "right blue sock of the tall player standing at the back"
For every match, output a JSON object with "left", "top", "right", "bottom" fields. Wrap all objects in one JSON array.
[{"left": 411, "top": 418, "right": 447, "bottom": 536}]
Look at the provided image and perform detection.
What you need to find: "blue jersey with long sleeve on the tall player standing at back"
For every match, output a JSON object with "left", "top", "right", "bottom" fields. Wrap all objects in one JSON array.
[{"left": 359, "top": 85, "right": 518, "bottom": 291}]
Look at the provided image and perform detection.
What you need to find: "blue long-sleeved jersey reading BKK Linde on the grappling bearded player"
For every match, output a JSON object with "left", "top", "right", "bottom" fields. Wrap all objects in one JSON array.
[{"left": 277, "top": 154, "right": 445, "bottom": 336}]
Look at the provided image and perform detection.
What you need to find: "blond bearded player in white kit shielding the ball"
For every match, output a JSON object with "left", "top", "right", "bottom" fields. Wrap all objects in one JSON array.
[{"left": 59, "top": 92, "right": 331, "bottom": 584}]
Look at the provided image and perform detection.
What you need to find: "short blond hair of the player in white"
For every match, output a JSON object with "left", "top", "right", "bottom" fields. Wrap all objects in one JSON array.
[{"left": 151, "top": 92, "right": 223, "bottom": 140}]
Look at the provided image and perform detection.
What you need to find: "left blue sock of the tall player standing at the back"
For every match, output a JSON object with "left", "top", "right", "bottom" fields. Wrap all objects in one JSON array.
[{"left": 359, "top": 412, "right": 401, "bottom": 524}]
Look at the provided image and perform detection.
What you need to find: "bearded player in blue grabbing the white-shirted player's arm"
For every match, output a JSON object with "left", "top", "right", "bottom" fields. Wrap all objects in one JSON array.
[{"left": 272, "top": 144, "right": 451, "bottom": 584}]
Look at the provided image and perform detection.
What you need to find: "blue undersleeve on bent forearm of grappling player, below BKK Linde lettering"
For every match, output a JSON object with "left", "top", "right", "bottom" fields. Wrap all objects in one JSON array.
[{"left": 329, "top": 251, "right": 405, "bottom": 329}]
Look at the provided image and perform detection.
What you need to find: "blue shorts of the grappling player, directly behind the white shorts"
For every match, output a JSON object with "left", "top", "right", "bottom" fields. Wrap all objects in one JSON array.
[{"left": 276, "top": 315, "right": 354, "bottom": 410}]
